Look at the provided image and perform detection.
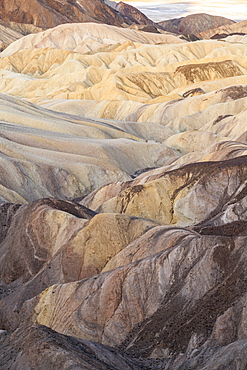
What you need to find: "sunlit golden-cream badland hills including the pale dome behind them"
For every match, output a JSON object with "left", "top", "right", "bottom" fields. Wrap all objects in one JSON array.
[{"left": 0, "top": 24, "right": 246, "bottom": 107}]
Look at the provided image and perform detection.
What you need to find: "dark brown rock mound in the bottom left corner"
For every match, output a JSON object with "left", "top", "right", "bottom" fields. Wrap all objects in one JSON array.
[{"left": 0, "top": 325, "right": 143, "bottom": 370}]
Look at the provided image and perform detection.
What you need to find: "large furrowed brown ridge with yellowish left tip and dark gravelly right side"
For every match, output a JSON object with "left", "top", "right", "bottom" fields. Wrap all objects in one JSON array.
[{"left": 2, "top": 215, "right": 246, "bottom": 357}]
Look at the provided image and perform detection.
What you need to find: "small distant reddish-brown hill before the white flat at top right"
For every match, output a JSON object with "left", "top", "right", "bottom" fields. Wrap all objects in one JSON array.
[{"left": 159, "top": 13, "right": 235, "bottom": 35}]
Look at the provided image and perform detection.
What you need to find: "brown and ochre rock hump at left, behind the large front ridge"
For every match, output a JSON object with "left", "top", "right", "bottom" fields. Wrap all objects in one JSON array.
[{"left": 0, "top": 199, "right": 158, "bottom": 327}]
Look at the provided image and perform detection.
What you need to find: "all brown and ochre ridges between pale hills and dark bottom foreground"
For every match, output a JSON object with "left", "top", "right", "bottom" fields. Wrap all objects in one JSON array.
[{"left": 0, "top": 153, "right": 247, "bottom": 369}]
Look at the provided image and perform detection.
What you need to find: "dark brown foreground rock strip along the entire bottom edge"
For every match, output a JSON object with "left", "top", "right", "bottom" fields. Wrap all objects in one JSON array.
[{"left": 0, "top": 325, "right": 247, "bottom": 370}]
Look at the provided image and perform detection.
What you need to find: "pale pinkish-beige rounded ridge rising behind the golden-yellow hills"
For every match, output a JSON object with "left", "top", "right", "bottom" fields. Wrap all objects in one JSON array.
[{"left": 1, "top": 23, "right": 184, "bottom": 56}]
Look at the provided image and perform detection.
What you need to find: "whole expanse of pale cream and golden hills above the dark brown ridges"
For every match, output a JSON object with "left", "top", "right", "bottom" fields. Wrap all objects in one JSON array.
[{"left": 0, "top": 24, "right": 247, "bottom": 202}]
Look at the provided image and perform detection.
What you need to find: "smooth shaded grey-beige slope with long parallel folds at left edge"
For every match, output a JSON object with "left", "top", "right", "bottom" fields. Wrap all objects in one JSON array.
[{"left": 0, "top": 95, "right": 176, "bottom": 201}]
